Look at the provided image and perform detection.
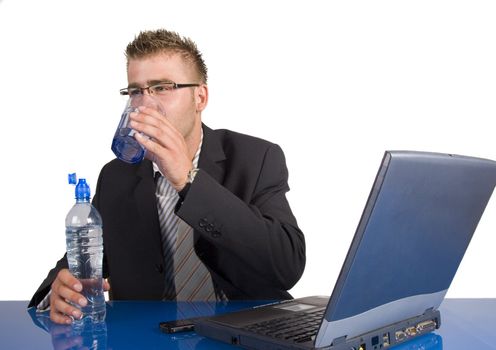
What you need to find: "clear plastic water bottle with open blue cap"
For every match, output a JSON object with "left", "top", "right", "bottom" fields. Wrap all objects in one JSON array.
[{"left": 65, "top": 174, "right": 106, "bottom": 324}]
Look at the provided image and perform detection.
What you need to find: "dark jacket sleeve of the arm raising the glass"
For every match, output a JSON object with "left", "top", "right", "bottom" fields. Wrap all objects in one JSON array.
[{"left": 177, "top": 144, "right": 305, "bottom": 291}]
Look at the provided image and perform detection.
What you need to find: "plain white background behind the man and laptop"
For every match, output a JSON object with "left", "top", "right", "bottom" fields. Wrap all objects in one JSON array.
[{"left": 0, "top": 0, "right": 496, "bottom": 300}]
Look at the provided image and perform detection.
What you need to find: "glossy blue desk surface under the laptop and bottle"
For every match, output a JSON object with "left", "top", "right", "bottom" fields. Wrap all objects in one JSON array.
[{"left": 0, "top": 299, "right": 496, "bottom": 350}]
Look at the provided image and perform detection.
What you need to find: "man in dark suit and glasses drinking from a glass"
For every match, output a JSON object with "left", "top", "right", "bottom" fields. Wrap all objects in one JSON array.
[{"left": 30, "top": 30, "right": 305, "bottom": 323}]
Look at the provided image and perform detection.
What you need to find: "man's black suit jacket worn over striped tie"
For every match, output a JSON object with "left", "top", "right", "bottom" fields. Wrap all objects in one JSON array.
[{"left": 30, "top": 125, "right": 305, "bottom": 305}]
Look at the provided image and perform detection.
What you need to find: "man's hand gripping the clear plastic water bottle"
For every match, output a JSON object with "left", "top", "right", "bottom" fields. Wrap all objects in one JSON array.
[{"left": 50, "top": 269, "right": 110, "bottom": 324}]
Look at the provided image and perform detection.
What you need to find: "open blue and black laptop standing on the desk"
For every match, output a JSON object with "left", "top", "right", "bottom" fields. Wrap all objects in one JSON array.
[{"left": 195, "top": 151, "right": 496, "bottom": 350}]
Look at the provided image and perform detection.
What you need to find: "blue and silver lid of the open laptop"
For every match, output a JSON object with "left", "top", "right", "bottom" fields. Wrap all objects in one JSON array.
[{"left": 315, "top": 151, "right": 496, "bottom": 347}]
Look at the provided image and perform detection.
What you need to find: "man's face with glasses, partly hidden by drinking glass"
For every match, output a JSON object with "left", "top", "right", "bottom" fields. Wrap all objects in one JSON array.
[{"left": 127, "top": 53, "right": 206, "bottom": 138}]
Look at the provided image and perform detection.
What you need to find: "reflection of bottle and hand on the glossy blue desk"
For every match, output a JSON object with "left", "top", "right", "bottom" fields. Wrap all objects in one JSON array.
[{"left": 50, "top": 322, "right": 110, "bottom": 350}]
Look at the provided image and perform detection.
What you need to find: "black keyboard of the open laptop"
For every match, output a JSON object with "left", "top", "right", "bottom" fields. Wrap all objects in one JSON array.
[{"left": 245, "top": 309, "right": 325, "bottom": 343}]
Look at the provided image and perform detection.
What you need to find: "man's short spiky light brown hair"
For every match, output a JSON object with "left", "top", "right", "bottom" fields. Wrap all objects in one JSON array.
[{"left": 126, "top": 29, "right": 208, "bottom": 84}]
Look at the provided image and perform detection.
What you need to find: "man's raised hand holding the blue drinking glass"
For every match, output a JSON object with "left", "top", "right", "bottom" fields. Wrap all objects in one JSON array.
[{"left": 130, "top": 107, "right": 192, "bottom": 192}]
